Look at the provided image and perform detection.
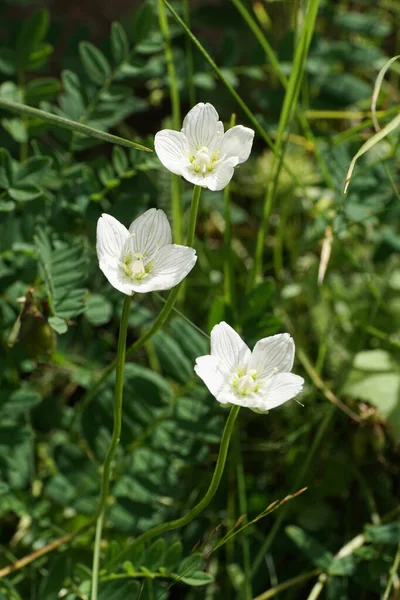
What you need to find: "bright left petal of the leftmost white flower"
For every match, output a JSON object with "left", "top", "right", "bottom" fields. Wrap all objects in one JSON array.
[{"left": 96, "top": 213, "right": 129, "bottom": 264}]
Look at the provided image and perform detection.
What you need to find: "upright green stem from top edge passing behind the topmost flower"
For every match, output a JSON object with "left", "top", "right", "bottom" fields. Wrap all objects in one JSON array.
[{"left": 157, "top": 0, "right": 182, "bottom": 244}]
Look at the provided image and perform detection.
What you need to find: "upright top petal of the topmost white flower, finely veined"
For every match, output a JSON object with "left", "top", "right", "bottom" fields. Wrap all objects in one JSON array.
[{"left": 182, "top": 102, "right": 219, "bottom": 151}]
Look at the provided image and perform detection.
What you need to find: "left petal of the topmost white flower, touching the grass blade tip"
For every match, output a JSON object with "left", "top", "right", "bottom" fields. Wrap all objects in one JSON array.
[{"left": 154, "top": 129, "right": 191, "bottom": 175}]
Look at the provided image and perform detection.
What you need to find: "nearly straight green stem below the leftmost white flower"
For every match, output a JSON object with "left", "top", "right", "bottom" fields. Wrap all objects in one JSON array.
[{"left": 91, "top": 296, "right": 132, "bottom": 600}]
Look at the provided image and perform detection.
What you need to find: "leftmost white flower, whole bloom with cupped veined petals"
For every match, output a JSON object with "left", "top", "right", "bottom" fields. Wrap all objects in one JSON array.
[{"left": 96, "top": 208, "right": 197, "bottom": 296}]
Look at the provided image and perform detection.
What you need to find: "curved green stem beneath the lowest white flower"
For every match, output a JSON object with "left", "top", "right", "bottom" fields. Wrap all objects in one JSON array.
[{"left": 107, "top": 406, "right": 240, "bottom": 568}]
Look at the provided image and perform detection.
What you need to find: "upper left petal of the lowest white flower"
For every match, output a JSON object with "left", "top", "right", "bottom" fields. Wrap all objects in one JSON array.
[{"left": 211, "top": 321, "right": 250, "bottom": 374}]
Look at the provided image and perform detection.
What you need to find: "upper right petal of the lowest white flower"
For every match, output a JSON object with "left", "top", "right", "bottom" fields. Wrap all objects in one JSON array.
[{"left": 249, "top": 333, "right": 294, "bottom": 378}]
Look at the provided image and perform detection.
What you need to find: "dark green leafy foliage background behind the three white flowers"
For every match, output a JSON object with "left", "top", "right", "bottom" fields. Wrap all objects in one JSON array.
[{"left": 0, "top": 0, "right": 400, "bottom": 600}]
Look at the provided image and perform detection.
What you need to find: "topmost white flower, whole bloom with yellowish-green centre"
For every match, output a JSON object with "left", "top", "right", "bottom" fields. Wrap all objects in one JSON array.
[{"left": 154, "top": 102, "right": 254, "bottom": 191}]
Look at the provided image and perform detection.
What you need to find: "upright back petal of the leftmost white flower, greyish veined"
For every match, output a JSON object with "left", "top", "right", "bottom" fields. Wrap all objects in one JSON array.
[{"left": 129, "top": 208, "right": 172, "bottom": 256}]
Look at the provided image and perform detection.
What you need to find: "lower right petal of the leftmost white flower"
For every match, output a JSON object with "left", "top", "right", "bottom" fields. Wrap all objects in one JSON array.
[{"left": 132, "top": 244, "right": 197, "bottom": 292}]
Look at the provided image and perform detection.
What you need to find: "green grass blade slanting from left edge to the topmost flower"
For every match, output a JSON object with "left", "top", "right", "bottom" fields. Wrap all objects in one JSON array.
[{"left": 0, "top": 98, "right": 152, "bottom": 152}]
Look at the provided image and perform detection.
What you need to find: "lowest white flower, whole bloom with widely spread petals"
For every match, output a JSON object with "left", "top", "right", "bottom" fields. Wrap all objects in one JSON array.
[{"left": 194, "top": 321, "right": 304, "bottom": 412}]
